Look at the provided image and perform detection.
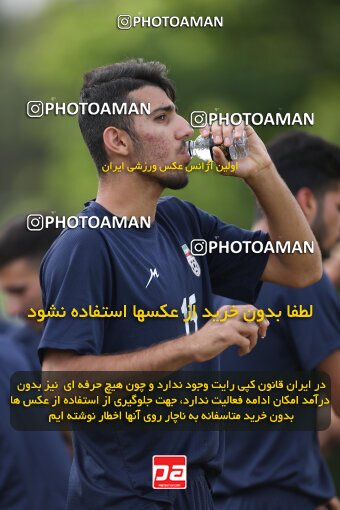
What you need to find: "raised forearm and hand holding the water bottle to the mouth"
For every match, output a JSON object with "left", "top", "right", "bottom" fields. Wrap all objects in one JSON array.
[{"left": 211, "top": 121, "right": 322, "bottom": 287}]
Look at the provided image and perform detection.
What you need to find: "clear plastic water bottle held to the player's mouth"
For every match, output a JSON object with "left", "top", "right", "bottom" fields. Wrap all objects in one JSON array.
[{"left": 186, "top": 129, "right": 249, "bottom": 161}]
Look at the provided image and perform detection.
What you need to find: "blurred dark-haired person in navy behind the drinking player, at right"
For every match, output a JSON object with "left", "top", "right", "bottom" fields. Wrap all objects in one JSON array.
[{"left": 214, "top": 133, "right": 340, "bottom": 510}]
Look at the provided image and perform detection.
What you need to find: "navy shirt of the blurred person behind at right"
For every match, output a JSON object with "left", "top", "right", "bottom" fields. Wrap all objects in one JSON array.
[{"left": 214, "top": 274, "right": 340, "bottom": 504}]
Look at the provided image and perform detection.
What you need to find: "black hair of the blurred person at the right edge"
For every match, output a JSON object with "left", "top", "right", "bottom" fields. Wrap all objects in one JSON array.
[{"left": 256, "top": 131, "right": 340, "bottom": 219}]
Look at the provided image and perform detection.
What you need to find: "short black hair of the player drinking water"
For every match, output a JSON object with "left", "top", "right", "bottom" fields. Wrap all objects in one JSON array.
[{"left": 78, "top": 58, "right": 176, "bottom": 172}]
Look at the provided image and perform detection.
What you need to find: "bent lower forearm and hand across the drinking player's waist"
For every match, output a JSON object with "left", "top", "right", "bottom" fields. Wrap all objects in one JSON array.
[{"left": 42, "top": 305, "right": 268, "bottom": 372}]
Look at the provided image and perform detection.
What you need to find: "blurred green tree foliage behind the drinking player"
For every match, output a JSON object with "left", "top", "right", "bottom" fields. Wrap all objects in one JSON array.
[{"left": 0, "top": 0, "right": 340, "bottom": 226}]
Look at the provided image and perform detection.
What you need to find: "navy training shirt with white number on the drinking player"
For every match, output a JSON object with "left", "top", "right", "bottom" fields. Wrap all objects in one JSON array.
[{"left": 40, "top": 197, "right": 268, "bottom": 510}]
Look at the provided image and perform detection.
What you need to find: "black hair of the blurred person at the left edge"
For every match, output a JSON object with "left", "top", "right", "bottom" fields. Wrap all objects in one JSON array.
[{"left": 0, "top": 213, "right": 62, "bottom": 268}]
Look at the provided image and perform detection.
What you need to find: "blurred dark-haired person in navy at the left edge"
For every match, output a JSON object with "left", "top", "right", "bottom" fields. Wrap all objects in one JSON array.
[{"left": 0, "top": 217, "right": 71, "bottom": 510}]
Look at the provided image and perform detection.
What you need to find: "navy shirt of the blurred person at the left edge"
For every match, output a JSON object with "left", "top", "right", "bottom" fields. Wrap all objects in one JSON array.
[{"left": 0, "top": 324, "right": 71, "bottom": 510}]
